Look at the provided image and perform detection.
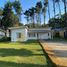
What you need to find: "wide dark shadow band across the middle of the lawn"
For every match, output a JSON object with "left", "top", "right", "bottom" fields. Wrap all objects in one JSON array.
[{"left": 0, "top": 48, "right": 44, "bottom": 57}]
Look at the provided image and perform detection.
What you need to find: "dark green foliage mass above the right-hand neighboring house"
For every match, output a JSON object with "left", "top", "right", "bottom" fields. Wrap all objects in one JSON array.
[{"left": 49, "top": 14, "right": 67, "bottom": 28}]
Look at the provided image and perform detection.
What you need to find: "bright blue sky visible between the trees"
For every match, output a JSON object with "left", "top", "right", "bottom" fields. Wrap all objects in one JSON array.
[{"left": 0, "top": 0, "right": 64, "bottom": 24}]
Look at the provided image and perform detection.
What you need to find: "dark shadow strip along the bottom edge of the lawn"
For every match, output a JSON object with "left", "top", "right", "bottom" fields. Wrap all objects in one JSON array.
[{"left": 0, "top": 61, "right": 48, "bottom": 67}]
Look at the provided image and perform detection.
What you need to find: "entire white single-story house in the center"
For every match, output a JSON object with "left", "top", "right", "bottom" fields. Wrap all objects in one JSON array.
[{"left": 9, "top": 26, "right": 52, "bottom": 42}]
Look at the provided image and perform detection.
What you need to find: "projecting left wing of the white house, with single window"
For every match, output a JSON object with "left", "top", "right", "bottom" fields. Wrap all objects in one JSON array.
[{"left": 9, "top": 27, "right": 28, "bottom": 42}]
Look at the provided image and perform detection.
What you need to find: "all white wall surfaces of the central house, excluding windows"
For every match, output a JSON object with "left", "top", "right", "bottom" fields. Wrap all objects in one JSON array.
[{"left": 11, "top": 28, "right": 51, "bottom": 41}]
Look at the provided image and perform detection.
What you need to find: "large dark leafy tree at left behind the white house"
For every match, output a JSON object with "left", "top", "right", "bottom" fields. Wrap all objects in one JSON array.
[{"left": 2, "top": 1, "right": 21, "bottom": 30}]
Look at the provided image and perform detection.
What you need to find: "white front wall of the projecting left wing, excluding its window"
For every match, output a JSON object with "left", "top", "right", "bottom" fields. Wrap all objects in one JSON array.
[{"left": 11, "top": 29, "right": 27, "bottom": 41}]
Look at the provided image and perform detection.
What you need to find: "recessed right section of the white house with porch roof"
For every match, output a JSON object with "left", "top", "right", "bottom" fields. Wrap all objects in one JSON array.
[{"left": 28, "top": 28, "right": 52, "bottom": 40}]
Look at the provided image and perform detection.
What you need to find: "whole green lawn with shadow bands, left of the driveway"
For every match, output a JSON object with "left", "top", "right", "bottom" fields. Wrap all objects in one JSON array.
[{"left": 0, "top": 41, "right": 53, "bottom": 67}]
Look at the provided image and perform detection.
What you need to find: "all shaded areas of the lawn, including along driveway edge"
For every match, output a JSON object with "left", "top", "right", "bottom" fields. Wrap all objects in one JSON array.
[{"left": 0, "top": 41, "right": 55, "bottom": 67}]
